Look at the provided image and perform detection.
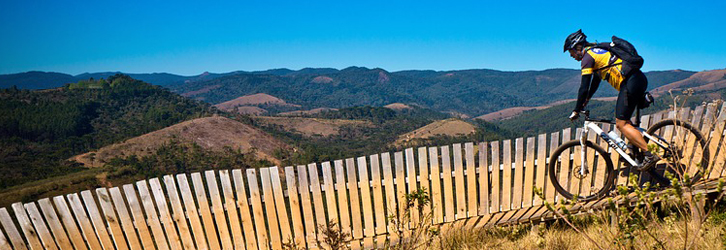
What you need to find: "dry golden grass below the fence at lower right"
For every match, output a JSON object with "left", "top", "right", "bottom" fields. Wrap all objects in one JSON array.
[{"left": 431, "top": 213, "right": 726, "bottom": 250}]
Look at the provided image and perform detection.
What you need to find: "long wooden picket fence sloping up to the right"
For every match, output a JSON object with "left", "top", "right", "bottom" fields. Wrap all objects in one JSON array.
[{"left": 0, "top": 101, "right": 726, "bottom": 249}]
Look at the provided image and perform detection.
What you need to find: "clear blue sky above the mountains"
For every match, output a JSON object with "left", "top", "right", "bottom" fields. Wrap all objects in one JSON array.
[{"left": 0, "top": 0, "right": 726, "bottom": 75}]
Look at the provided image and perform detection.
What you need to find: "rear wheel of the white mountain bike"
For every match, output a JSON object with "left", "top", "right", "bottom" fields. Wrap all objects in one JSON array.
[{"left": 646, "top": 119, "right": 709, "bottom": 184}]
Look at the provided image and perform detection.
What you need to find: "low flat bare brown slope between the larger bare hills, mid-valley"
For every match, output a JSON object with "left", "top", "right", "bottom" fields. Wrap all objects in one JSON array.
[{"left": 257, "top": 116, "right": 373, "bottom": 136}]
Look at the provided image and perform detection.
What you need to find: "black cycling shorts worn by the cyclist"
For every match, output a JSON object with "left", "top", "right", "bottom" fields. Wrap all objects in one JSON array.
[{"left": 615, "top": 70, "right": 648, "bottom": 120}]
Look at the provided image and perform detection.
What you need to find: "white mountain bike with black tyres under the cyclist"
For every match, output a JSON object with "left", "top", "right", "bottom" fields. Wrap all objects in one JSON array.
[{"left": 547, "top": 109, "right": 709, "bottom": 201}]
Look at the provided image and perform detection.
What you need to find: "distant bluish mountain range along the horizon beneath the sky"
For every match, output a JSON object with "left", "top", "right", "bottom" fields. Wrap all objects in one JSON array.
[{"left": 0, "top": 67, "right": 696, "bottom": 117}]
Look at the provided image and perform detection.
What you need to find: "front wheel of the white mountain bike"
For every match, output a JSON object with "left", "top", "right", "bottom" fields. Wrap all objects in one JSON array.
[{"left": 547, "top": 140, "right": 615, "bottom": 201}]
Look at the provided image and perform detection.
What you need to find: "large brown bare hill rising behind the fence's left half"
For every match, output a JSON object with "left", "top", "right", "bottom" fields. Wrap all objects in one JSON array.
[{"left": 71, "top": 116, "right": 290, "bottom": 167}]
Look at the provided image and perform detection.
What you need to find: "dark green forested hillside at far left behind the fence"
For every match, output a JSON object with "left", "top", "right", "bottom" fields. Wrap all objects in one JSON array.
[{"left": 0, "top": 75, "right": 217, "bottom": 190}]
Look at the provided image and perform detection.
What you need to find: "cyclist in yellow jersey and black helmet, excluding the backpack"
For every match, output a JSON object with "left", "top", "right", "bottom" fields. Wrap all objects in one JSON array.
[{"left": 563, "top": 30, "right": 659, "bottom": 170}]
